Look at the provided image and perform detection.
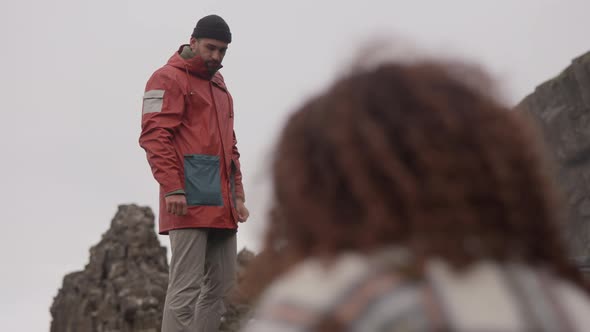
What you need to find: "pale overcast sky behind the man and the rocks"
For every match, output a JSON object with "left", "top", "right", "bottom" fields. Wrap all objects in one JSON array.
[{"left": 0, "top": 0, "right": 590, "bottom": 332}]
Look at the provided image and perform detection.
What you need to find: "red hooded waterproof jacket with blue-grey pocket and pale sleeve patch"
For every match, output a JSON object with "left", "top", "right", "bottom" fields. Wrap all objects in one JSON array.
[{"left": 139, "top": 45, "right": 244, "bottom": 234}]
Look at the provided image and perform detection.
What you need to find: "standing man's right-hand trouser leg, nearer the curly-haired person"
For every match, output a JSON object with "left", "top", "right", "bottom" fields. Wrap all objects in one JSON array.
[{"left": 195, "top": 229, "right": 237, "bottom": 332}]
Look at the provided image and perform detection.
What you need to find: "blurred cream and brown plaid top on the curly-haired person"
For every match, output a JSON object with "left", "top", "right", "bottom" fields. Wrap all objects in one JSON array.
[{"left": 245, "top": 249, "right": 590, "bottom": 332}]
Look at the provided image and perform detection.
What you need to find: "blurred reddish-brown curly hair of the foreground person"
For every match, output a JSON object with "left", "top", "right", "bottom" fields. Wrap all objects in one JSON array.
[{"left": 244, "top": 59, "right": 583, "bottom": 298}]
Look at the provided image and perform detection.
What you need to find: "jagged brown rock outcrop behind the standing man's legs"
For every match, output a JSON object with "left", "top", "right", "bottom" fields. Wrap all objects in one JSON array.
[{"left": 51, "top": 205, "right": 254, "bottom": 332}]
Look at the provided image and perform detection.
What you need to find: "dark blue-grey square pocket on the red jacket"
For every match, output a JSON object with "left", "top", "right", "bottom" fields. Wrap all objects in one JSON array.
[{"left": 184, "top": 154, "right": 223, "bottom": 206}]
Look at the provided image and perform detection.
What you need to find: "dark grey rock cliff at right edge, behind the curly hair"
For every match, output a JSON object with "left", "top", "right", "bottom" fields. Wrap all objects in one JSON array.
[{"left": 517, "top": 52, "right": 590, "bottom": 266}]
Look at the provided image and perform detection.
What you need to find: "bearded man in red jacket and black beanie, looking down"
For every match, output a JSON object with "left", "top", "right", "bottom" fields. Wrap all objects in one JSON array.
[{"left": 139, "top": 15, "right": 249, "bottom": 332}]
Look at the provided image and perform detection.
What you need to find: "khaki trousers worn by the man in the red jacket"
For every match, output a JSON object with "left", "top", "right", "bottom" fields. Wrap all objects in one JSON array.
[{"left": 162, "top": 228, "right": 237, "bottom": 332}]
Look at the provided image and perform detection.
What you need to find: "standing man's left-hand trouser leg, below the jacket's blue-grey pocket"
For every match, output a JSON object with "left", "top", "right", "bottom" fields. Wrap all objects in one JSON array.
[{"left": 162, "top": 228, "right": 208, "bottom": 332}]
